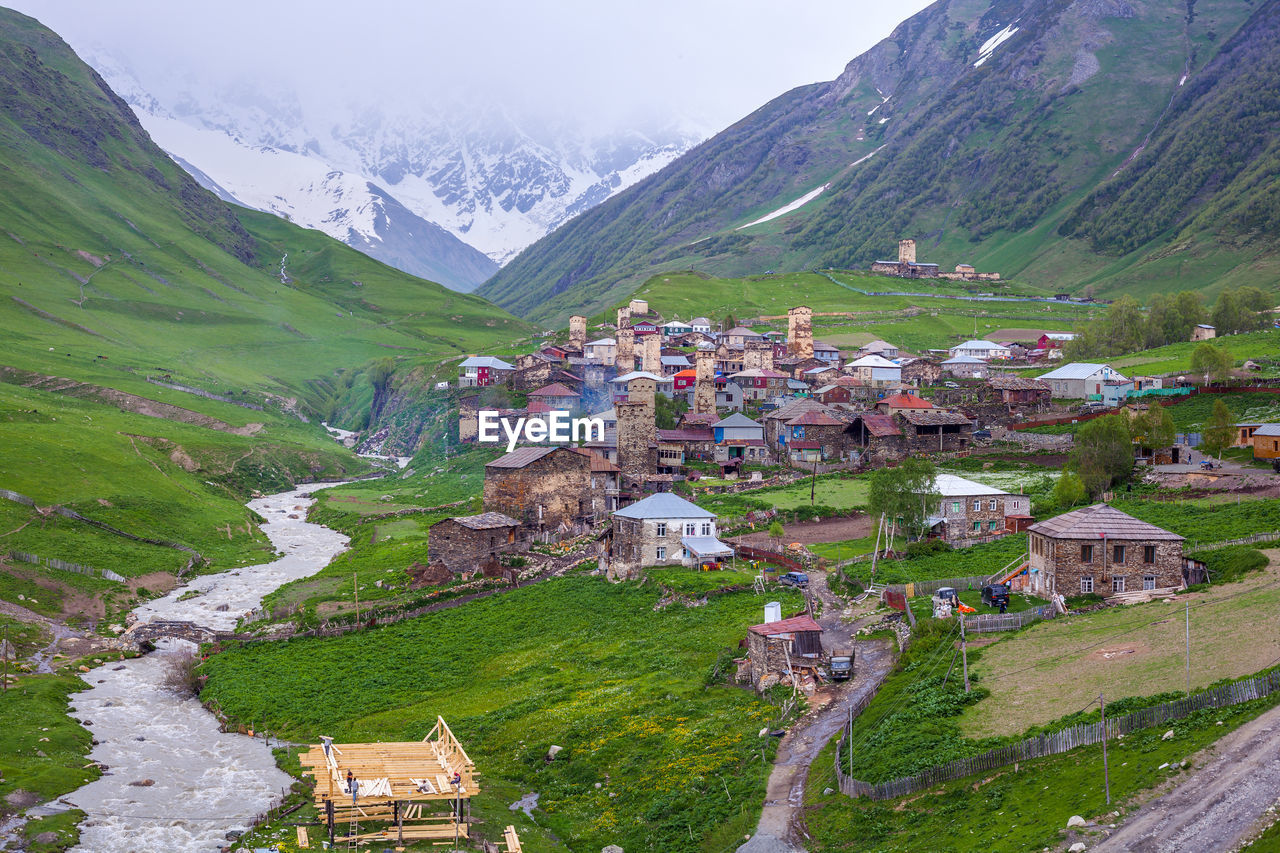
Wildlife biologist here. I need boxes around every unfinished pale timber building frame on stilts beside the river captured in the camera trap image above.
[300,716,479,847]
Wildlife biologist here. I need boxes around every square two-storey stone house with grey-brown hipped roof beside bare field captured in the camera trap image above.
[1027,503,1184,598]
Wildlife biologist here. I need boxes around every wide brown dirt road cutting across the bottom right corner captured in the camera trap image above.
[1091,708,1280,853]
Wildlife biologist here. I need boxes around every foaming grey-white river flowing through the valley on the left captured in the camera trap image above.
[61,484,347,853]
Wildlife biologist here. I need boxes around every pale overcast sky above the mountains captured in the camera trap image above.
[0,0,927,131]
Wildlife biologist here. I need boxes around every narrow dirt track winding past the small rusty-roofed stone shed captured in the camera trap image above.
[737,571,895,853]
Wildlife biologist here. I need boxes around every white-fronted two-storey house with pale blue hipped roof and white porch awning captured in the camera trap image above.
[607,492,733,580]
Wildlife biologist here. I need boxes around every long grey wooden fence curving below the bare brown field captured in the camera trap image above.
[836,670,1280,799]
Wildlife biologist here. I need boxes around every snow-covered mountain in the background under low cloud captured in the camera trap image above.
[88,53,705,291]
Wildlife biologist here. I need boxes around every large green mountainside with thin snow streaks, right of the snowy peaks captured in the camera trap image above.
[479,0,1280,319]
